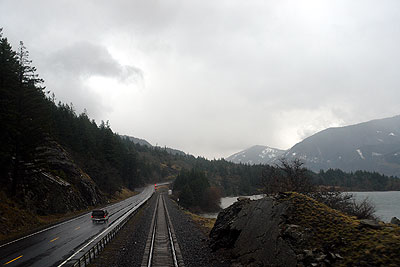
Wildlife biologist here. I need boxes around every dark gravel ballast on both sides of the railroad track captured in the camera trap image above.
[91,194,230,267]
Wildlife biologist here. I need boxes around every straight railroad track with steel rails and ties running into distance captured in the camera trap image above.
[141,194,184,267]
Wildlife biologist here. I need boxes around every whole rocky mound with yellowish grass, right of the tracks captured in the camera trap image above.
[210,193,400,266]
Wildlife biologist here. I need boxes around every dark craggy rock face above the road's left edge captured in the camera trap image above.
[22,142,106,215]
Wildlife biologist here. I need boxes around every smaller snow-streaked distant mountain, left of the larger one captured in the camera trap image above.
[226,146,285,164]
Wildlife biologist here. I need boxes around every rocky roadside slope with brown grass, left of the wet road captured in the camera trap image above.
[0,141,107,241]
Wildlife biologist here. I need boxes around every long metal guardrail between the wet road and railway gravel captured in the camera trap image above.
[71,194,153,267]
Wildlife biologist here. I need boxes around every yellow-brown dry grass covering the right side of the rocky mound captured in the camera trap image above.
[284,193,400,266]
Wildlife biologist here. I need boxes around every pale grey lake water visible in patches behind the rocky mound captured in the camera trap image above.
[202,191,400,222]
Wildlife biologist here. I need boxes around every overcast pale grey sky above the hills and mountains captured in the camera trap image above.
[0,0,400,159]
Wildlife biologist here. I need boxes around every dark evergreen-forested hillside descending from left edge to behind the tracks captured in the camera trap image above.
[0,28,261,206]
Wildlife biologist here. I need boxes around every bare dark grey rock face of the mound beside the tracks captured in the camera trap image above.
[210,198,297,266]
